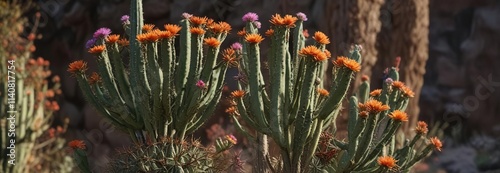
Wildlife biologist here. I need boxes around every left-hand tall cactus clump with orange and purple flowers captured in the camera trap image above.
[68,0,232,143]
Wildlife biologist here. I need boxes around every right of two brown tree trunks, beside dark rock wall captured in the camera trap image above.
[390,0,429,135]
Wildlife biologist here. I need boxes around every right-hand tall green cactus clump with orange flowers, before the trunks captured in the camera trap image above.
[226,13,440,172]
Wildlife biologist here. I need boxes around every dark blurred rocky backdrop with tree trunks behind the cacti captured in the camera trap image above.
[6,0,500,173]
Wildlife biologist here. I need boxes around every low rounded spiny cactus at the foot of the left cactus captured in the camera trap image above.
[107,135,237,172]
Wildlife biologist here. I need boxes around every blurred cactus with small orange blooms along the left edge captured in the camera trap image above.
[0,1,72,173]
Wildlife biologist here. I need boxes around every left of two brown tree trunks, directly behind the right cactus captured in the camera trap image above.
[318,0,384,86]
